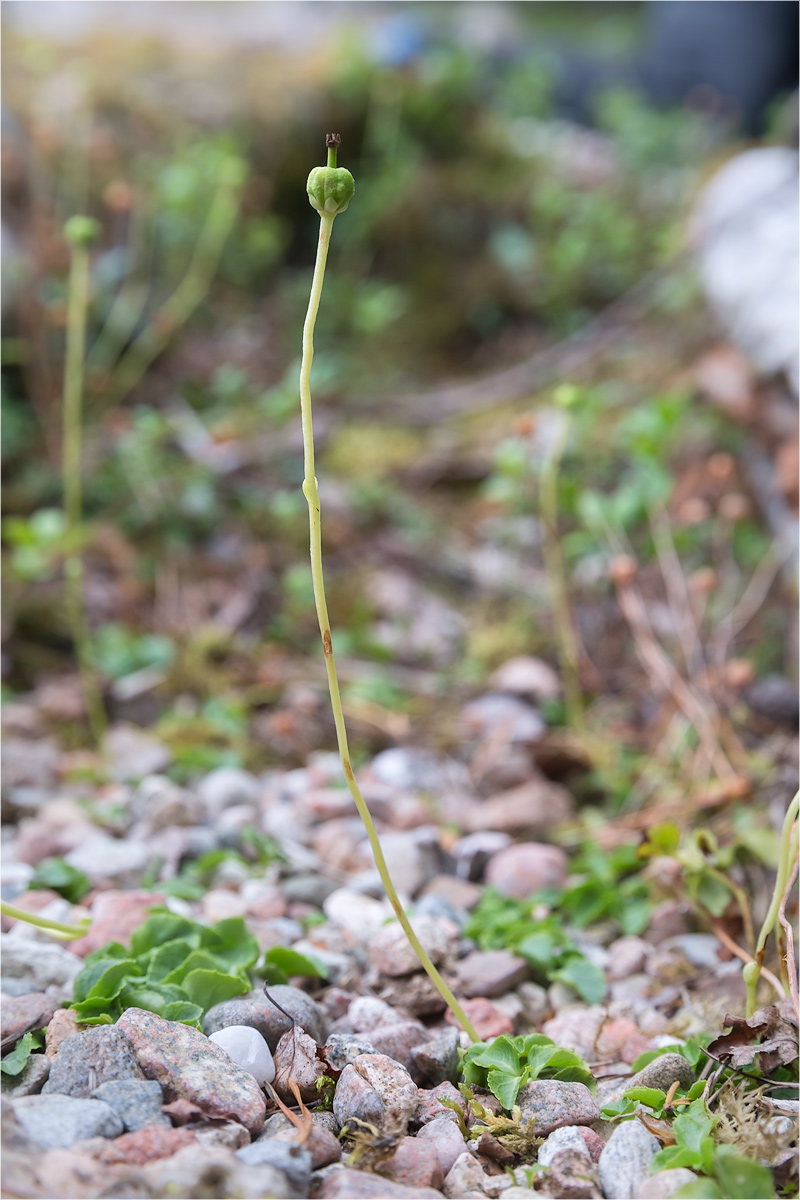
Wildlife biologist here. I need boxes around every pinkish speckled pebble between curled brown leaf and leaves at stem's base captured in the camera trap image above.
[333,1054,419,1136]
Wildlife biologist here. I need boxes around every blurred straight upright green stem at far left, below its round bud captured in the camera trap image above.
[62,235,107,749]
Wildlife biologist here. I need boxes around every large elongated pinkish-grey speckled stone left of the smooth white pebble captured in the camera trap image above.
[116,1008,266,1134]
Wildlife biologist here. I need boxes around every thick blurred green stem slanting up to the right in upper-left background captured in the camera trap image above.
[106,175,240,403]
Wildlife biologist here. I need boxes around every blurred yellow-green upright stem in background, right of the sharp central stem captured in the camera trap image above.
[539,418,583,730]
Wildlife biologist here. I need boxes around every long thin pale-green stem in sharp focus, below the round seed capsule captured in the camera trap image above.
[300,212,480,1042]
